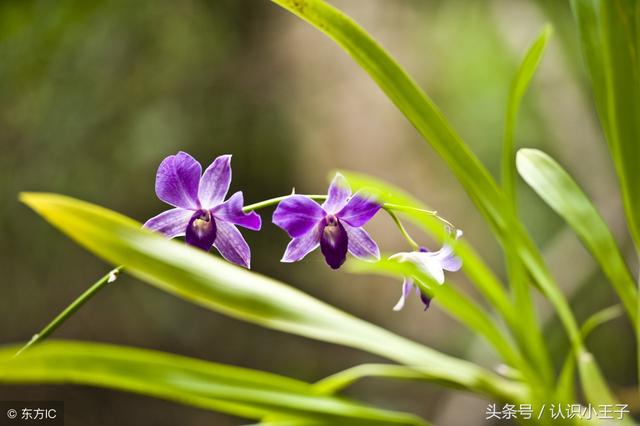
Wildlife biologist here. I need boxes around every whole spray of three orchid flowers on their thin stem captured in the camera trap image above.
[144,151,462,310]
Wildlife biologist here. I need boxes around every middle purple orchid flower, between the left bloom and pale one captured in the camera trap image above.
[273,173,381,269]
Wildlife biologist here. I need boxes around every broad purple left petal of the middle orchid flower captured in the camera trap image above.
[273,195,325,238]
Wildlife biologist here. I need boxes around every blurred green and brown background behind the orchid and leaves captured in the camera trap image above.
[0,0,638,425]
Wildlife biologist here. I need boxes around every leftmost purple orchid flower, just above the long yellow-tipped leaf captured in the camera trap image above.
[144,151,261,268]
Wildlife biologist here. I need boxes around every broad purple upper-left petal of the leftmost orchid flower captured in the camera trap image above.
[156,151,202,210]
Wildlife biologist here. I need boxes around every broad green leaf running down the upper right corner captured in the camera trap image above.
[571,0,640,250]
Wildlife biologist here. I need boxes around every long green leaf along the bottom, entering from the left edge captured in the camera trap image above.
[0,341,424,425]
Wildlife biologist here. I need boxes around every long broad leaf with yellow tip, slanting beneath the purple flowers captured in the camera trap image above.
[21,193,523,399]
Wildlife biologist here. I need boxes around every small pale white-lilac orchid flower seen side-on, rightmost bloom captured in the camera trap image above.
[389,229,462,311]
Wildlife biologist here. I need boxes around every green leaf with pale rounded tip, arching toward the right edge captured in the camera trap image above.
[517,149,638,326]
